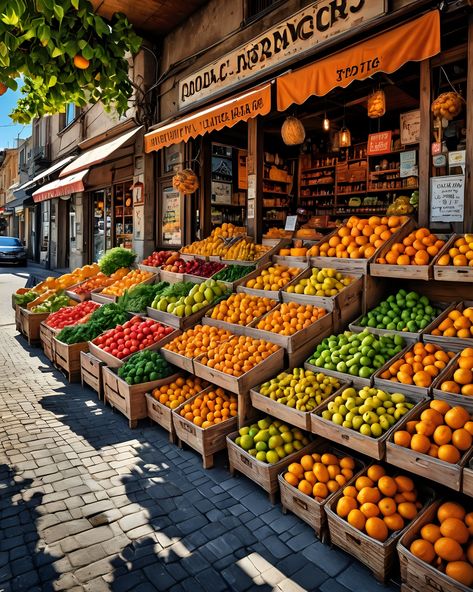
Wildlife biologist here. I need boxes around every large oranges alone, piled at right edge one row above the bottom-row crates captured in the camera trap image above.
[394,399,473,464]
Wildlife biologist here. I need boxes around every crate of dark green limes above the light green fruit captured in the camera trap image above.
[349,289,445,341]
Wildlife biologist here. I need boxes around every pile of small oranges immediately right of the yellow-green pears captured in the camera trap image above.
[210,292,277,326]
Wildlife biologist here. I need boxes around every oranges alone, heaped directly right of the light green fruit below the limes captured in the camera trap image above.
[380,343,455,388]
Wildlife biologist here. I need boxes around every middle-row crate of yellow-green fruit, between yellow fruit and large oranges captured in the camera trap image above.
[311,386,425,460]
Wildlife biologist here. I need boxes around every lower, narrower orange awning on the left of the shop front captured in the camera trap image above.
[145,84,271,152]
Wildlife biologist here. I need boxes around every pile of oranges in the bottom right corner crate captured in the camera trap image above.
[409,501,473,587]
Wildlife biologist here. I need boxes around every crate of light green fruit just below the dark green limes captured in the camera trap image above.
[304,329,405,387]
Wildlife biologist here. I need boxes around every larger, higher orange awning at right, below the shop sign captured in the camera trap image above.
[277,10,440,111]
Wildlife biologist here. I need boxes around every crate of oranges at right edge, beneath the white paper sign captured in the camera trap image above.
[434,234,473,282]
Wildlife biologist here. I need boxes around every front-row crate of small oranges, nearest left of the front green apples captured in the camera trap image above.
[172,385,238,469]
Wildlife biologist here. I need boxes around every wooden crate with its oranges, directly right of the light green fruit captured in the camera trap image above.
[374,341,455,396]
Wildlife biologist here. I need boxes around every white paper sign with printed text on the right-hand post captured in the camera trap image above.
[430,175,465,222]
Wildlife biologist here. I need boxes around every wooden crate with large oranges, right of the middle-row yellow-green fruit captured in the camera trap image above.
[386,399,473,491]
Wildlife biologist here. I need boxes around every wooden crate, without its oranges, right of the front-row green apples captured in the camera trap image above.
[278,440,366,542]
